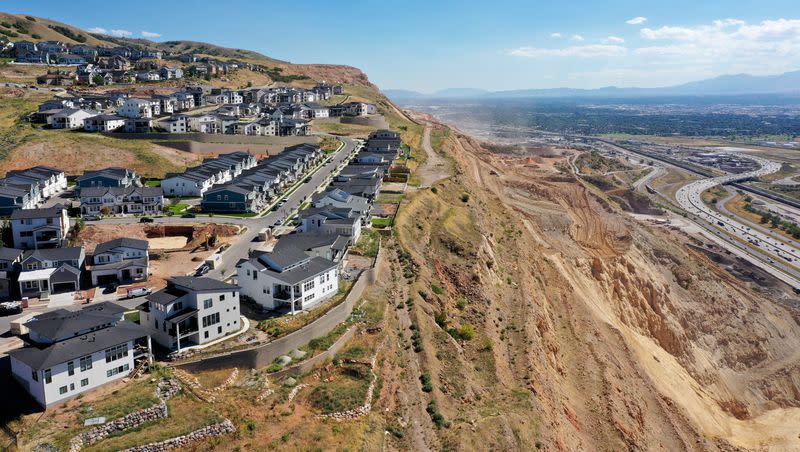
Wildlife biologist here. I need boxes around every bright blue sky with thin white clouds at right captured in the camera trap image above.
[6,0,800,92]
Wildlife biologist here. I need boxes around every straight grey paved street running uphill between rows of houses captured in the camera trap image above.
[206,138,358,279]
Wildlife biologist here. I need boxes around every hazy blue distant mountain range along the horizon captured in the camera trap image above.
[383,71,800,100]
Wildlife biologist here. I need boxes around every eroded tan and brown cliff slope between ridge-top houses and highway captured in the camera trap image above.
[384,128,800,450]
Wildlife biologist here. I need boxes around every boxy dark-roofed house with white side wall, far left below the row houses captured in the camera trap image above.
[10,204,70,249]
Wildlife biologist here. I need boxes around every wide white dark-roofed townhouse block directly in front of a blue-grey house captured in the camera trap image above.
[80,185,164,217]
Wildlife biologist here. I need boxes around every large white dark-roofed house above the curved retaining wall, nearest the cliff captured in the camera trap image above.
[236,240,339,315]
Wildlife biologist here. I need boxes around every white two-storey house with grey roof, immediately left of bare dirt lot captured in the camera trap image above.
[89,238,150,286]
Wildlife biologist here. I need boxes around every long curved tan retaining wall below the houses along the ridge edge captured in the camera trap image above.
[175,247,384,371]
